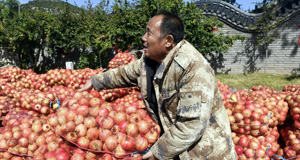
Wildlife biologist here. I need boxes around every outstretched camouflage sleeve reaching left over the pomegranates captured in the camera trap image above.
[91,58,142,91]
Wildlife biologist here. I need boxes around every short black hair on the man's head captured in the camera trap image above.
[155,11,184,44]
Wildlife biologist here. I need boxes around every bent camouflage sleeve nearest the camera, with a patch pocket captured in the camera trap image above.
[151,63,216,159]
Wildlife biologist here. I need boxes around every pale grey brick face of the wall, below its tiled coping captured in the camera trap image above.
[216,15,300,74]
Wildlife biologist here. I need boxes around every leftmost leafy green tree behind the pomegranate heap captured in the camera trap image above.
[2,10,51,71]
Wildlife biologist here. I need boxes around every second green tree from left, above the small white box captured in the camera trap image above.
[47,3,85,68]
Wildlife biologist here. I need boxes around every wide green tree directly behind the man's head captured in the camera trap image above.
[101,0,242,55]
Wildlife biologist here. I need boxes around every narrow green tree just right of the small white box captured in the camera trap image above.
[77,0,112,69]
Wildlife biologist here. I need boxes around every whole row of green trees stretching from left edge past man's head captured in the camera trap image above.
[0,0,242,71]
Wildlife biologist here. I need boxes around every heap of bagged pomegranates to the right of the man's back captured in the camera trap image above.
[218,82,300,160]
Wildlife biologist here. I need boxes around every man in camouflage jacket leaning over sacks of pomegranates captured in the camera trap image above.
[80,12,237,160]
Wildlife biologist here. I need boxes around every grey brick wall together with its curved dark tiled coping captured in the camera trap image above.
[196,0,300,74]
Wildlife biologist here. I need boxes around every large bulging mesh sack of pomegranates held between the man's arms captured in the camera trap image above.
[48,90,160,158]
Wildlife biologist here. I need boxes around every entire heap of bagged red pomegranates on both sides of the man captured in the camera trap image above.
[0,49,300,160]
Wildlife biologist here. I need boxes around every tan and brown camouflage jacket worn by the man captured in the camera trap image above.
[91,40,237,160]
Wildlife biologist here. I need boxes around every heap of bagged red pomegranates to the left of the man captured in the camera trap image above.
[0,53,160,160]
